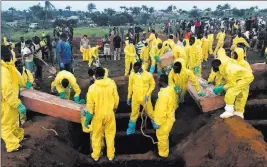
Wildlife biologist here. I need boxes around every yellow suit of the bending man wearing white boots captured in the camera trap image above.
[219,61,254,113]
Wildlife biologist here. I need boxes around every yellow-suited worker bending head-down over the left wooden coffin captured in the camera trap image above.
[51,70,85,104]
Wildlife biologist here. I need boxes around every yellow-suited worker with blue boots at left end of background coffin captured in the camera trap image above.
[149,43,165,74]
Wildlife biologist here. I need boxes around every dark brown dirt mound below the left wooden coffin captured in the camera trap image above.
[1,116,79,167]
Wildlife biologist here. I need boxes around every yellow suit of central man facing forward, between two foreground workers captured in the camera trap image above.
[127,71,155,122]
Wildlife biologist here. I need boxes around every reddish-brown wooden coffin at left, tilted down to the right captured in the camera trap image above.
[20,89,85,123]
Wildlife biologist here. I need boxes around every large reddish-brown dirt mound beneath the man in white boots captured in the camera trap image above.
[175,117,267,167]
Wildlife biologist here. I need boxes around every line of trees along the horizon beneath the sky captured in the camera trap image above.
[2,1,267,26]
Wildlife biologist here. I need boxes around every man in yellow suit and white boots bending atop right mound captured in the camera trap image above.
[211,59,254,118]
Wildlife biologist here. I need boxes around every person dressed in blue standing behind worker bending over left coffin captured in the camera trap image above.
[56,33,73,73]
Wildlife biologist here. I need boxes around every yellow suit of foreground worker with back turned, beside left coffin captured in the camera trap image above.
[86,78,119,160]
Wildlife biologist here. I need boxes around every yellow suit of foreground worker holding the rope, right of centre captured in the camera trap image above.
[154,86,177,157]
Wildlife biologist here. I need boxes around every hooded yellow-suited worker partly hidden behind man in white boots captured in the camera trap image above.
[231,48,252,72]
